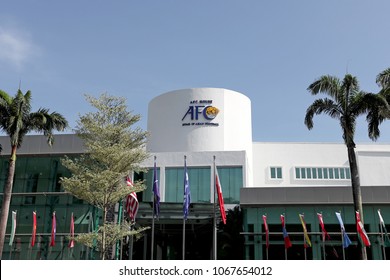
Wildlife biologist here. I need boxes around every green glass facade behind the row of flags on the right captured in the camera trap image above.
[244,205,390,260]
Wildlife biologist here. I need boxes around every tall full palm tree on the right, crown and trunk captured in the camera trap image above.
[305,74,386,259]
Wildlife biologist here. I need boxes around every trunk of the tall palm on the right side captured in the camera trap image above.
[347,146,367,260]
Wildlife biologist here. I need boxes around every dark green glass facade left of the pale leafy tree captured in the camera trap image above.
[0,156,93,259]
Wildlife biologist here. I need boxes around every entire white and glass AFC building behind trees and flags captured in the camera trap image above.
[0,88,390,260]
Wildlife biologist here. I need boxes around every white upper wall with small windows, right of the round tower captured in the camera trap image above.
[253,142,390,187]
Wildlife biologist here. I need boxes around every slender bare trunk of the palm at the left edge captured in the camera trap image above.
[0,146,16,260]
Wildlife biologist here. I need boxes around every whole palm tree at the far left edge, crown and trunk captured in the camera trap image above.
[0,89,68,259]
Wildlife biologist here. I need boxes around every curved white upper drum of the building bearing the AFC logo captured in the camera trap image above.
[147,88,252,155]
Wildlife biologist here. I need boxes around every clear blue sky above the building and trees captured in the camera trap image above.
[0,0,390,143]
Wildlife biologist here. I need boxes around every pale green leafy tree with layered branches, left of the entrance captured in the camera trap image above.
[61,94,148,259]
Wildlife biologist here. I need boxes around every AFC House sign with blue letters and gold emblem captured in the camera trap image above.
[181,100,219,126]
